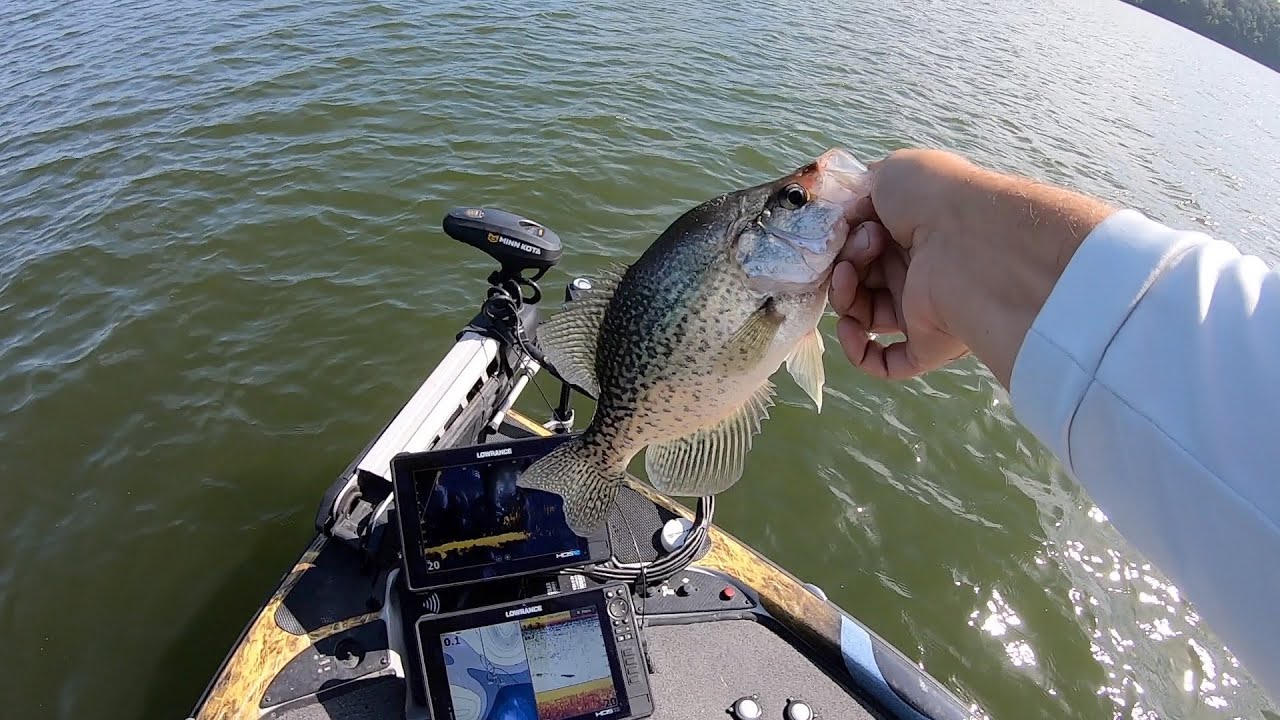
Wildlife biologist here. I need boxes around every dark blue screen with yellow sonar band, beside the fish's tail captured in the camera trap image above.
[406,459,590,587]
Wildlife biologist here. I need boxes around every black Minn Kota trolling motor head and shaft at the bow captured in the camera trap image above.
[442,208,581,422]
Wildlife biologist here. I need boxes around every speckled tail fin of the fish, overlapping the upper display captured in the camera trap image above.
[516,436,627,537]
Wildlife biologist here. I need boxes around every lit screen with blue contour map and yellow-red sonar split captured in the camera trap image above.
[440,607,620,720]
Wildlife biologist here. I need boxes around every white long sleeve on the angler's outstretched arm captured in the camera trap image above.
[1010,210,1280,700]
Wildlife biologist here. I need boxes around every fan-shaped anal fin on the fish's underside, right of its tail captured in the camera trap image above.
[644,380,773,497]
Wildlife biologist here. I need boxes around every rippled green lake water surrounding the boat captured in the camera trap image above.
[0,0,1280,720]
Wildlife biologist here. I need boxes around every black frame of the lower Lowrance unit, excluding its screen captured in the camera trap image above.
[415,585,631,720]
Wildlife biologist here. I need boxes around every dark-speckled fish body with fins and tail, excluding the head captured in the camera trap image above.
[521,165,824,534]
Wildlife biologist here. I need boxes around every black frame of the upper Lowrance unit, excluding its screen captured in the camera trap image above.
[392,432,609,592]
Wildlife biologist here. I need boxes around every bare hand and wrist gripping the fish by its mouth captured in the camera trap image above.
[829,150,1112,388]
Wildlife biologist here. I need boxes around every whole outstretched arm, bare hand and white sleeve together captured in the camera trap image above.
[855,150,1280,693]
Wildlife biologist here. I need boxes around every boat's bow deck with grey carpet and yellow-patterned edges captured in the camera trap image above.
[192,386,969,720]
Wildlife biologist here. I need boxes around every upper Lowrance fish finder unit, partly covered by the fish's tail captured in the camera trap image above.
[392,433,609,592]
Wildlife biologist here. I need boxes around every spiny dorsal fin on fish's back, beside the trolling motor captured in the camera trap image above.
[538,265,626,397]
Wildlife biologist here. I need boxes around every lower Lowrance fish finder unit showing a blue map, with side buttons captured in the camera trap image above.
[417,583,653,720]
